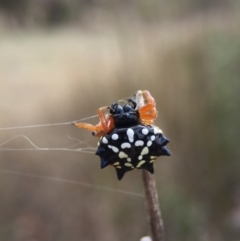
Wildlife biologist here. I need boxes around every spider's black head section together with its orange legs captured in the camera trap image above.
[74,90,157,137]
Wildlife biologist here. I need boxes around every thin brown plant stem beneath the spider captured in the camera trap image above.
[142,170,164,241]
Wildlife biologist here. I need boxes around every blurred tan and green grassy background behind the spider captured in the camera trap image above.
[0,0,240,241]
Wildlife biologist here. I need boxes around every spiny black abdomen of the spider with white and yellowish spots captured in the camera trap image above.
[96,125,170,180]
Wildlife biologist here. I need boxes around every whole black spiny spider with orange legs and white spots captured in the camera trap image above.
[74,90,170,180]
